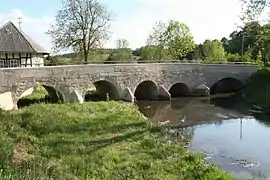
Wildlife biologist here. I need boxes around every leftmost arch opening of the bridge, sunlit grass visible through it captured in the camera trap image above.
[15,84,65,108]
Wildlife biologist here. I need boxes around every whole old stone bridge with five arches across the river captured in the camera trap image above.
[0,63,258,109]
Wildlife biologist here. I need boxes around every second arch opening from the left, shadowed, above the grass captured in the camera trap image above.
[84,79,120,101]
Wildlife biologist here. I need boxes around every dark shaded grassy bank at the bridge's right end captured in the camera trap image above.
[245,69,270,109]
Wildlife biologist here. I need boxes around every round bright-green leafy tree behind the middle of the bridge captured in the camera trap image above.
[147,21,195,60]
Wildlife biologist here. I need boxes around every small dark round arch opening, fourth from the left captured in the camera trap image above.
[169,83,191,98]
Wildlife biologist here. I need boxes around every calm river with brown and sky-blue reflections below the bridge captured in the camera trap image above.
[137,96,270,180]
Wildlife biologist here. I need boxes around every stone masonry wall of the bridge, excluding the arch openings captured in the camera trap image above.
[0,63,257,109]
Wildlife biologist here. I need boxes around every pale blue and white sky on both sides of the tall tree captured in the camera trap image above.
[0,0,244,51]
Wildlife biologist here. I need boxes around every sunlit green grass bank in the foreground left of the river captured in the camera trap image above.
[0,102,231,180]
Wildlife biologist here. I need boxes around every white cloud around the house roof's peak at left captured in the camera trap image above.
[0,9,53,51]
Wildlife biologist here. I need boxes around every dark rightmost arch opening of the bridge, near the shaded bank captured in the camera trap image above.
[210,77,244,95]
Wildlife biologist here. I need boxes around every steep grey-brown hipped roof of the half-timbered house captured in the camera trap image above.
[0,22,48,54]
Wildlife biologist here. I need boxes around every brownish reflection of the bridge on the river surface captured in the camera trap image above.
[137,97,244,128]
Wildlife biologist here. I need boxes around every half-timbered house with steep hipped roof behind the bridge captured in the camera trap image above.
[0,22,49,68]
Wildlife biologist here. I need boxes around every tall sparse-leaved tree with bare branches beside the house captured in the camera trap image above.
[47,0,111,62]
